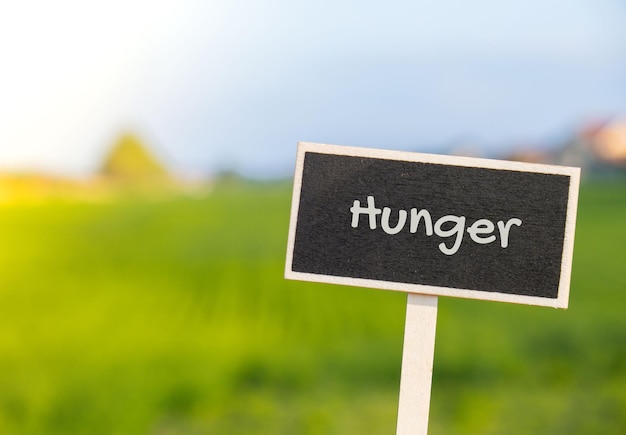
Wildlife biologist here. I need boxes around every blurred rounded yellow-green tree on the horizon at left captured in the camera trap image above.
[101,132,172,183]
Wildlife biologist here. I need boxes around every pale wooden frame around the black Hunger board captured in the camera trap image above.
[285,142,580,308]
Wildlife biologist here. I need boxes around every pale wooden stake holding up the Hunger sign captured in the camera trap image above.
[396,293,437,435]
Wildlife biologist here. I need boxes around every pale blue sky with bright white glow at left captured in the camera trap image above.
[0,0,626,177]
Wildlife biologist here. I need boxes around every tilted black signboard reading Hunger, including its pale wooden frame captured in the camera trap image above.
[285,143,580,308]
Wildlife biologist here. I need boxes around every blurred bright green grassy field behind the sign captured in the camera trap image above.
[0,184,626,435]
